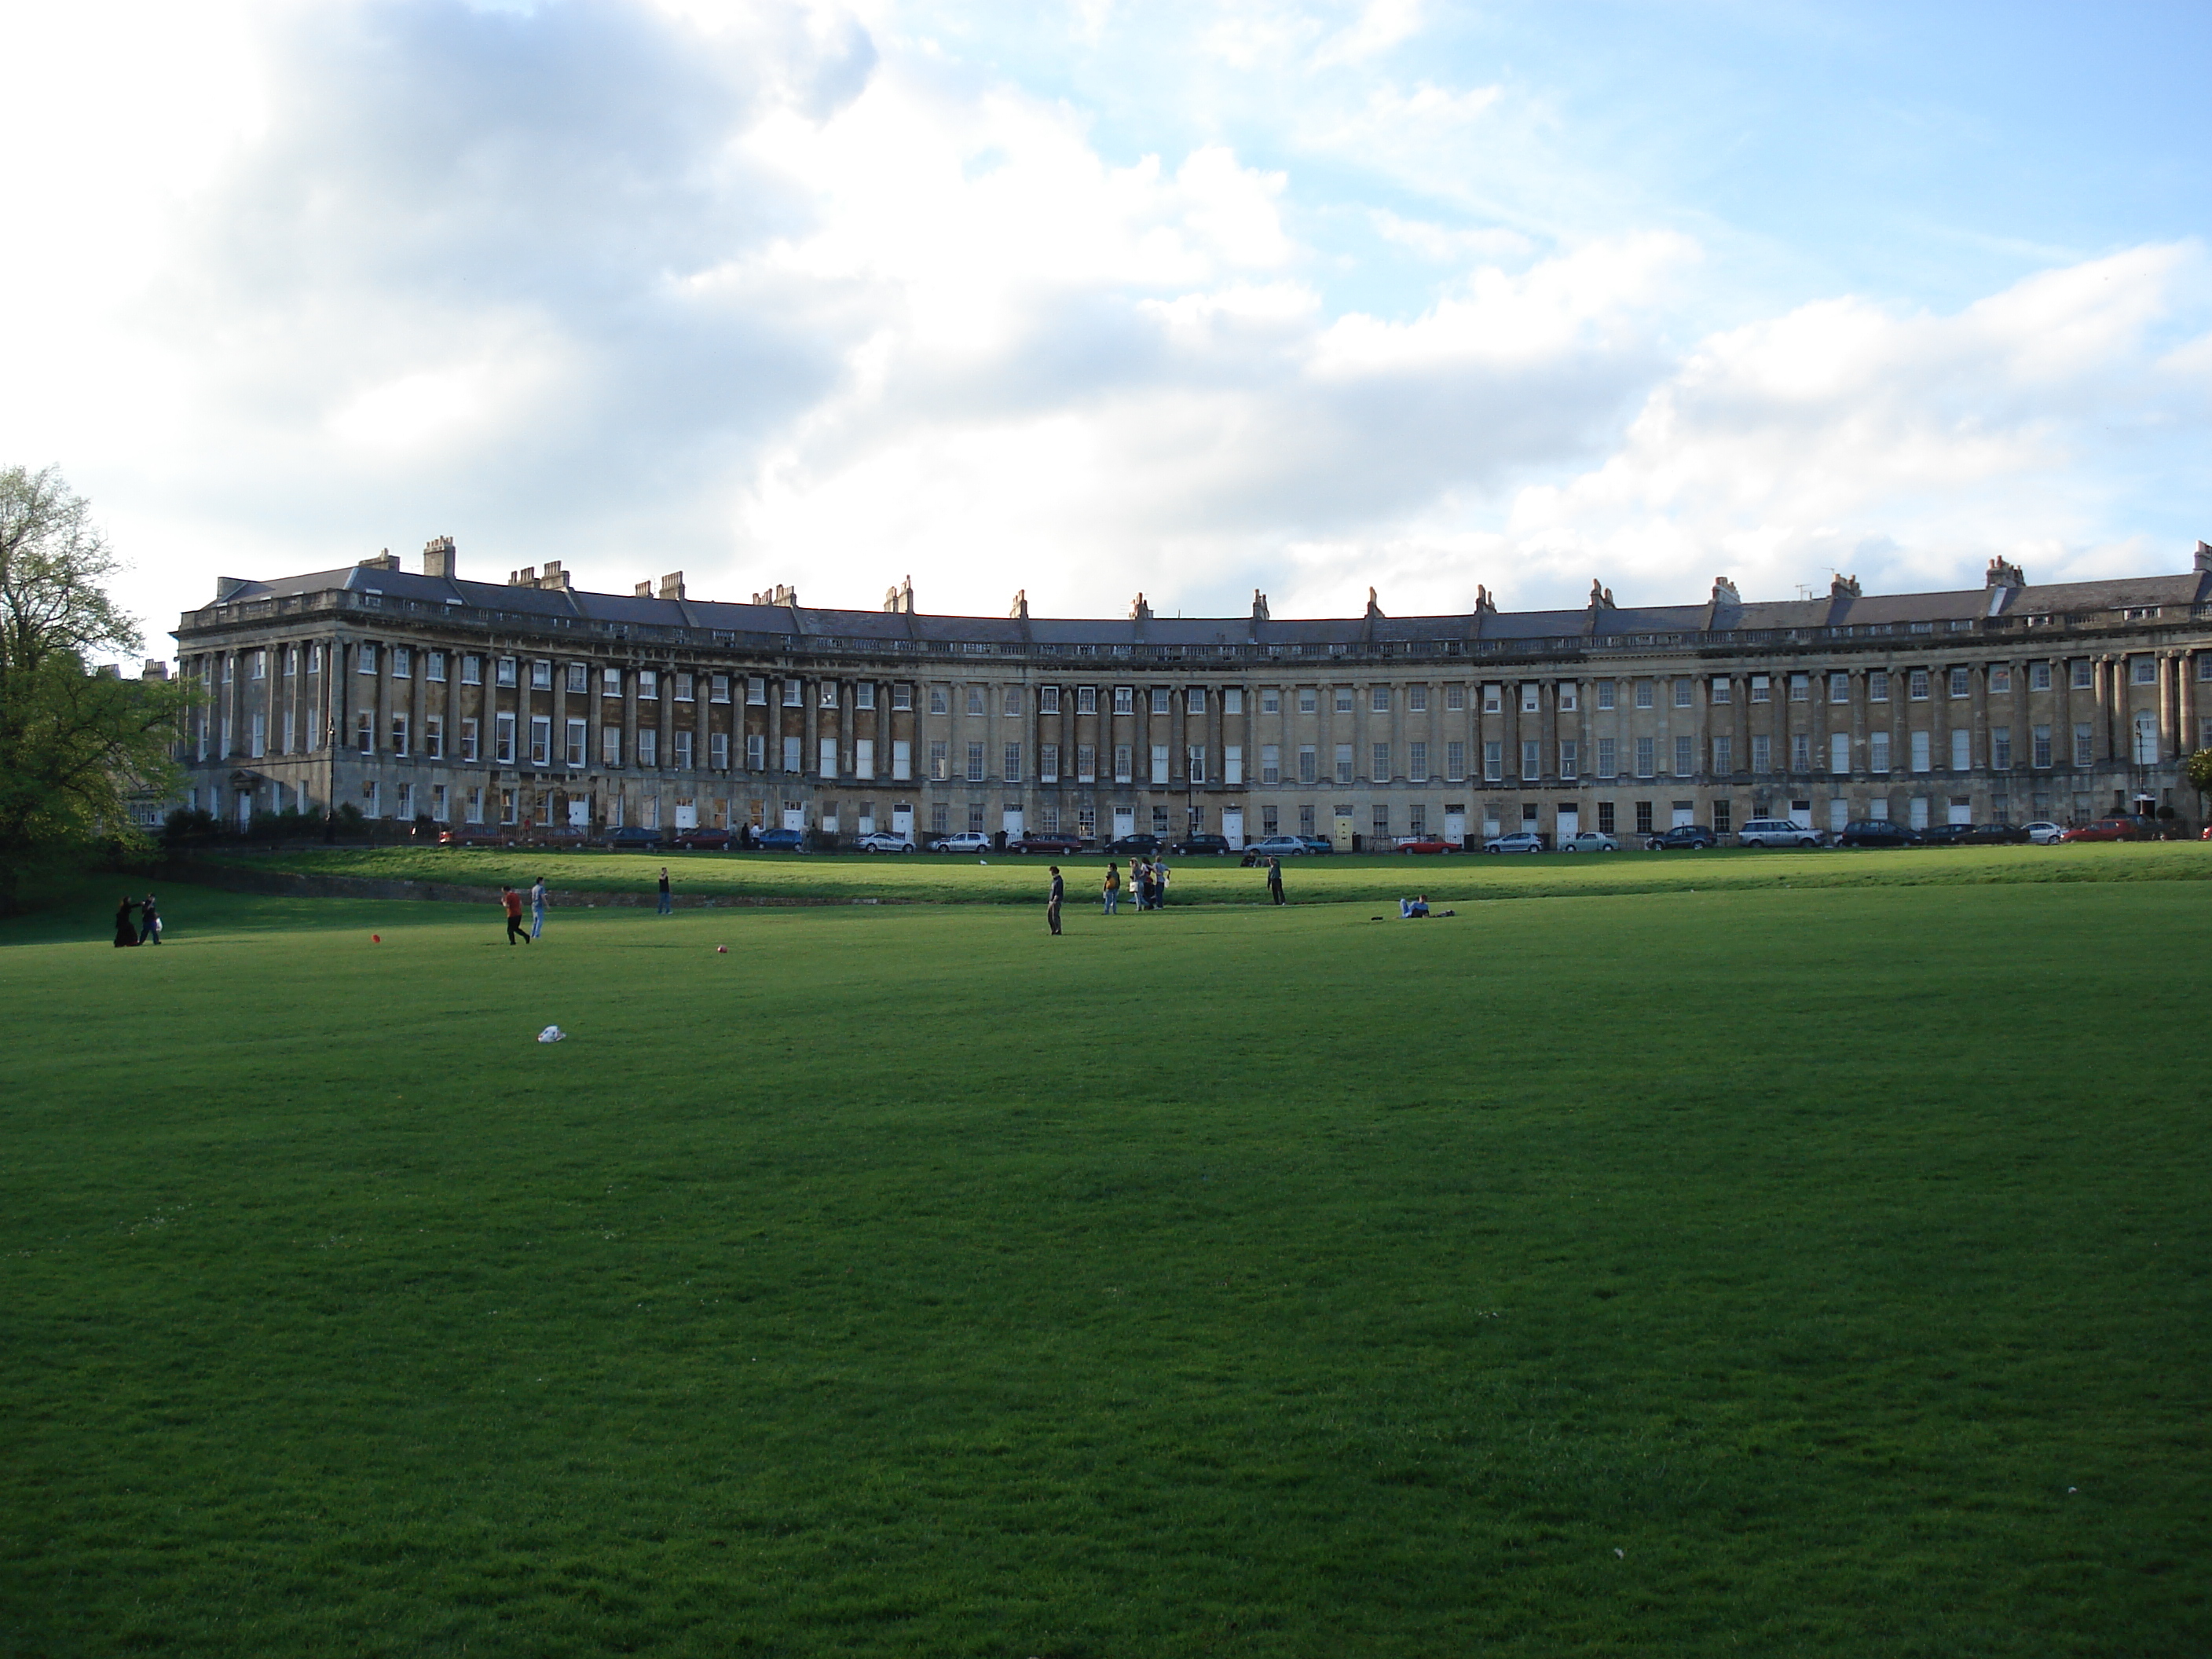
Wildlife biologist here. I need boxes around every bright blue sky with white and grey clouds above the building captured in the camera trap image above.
[0,0,2212,655]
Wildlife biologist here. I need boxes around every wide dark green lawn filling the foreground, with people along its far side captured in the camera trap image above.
[0,876,2212,1659]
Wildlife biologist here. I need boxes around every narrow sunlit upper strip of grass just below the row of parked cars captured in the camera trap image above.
[194,840,2212,905]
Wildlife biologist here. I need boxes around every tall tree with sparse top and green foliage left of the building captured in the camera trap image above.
[0,467,186,911]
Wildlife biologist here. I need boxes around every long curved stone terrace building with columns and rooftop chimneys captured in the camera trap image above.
[177,537,2212,843]
